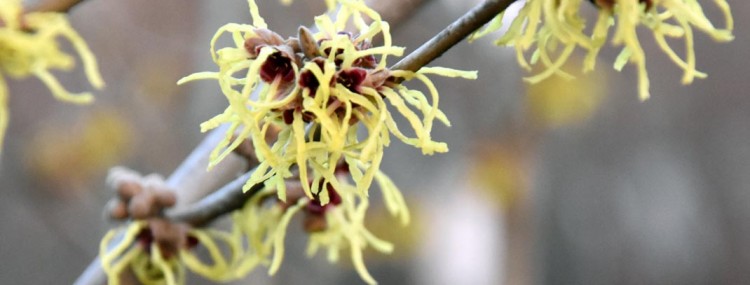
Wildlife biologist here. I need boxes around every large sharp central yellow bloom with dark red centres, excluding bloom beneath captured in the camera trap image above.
[178,1,476,204]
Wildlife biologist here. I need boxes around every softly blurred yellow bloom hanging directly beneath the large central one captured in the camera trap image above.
[234,164,409,284]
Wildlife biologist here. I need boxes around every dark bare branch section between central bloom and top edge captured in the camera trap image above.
[391,0,516,71]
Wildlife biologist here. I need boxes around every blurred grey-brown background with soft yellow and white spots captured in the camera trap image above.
[0,0,750,284]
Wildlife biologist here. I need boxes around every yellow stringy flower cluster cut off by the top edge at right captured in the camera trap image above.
[472,0,734,100]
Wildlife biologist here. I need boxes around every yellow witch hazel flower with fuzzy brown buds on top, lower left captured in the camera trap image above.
[99,167,248,285]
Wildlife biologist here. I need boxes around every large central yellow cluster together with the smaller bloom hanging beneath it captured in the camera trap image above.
[173,0,476,283]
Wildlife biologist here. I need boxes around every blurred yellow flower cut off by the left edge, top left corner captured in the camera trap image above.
[0,0,104,149]
